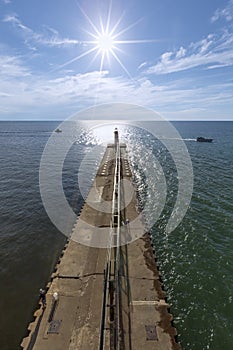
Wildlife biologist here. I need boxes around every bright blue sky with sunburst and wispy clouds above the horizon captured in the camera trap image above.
[0,0,233,120]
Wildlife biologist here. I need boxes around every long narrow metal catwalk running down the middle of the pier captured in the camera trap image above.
[99,137,121,350]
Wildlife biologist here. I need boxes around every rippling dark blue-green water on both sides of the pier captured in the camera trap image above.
[0,122,233,350]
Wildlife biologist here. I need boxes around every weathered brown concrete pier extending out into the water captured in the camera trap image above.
[21,135,181,350]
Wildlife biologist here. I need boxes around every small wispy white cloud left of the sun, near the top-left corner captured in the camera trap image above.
[3,14,81,47]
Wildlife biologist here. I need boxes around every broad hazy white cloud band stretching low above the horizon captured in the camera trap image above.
[0,52,233,118]
